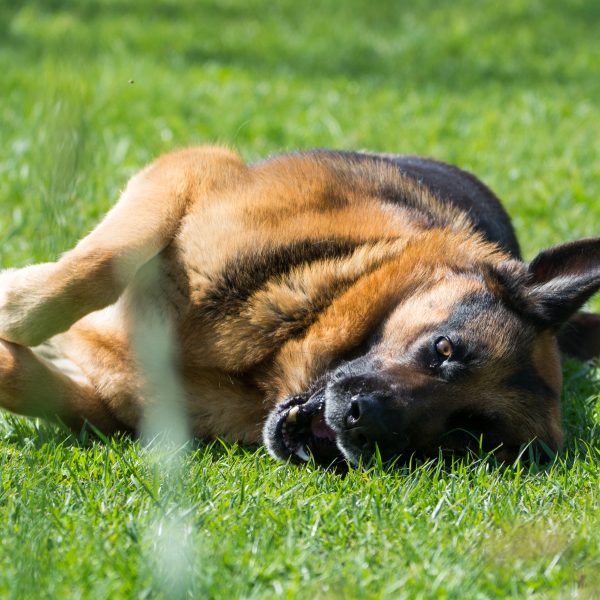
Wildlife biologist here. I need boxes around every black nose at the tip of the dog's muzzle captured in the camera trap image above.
[344,392,389,448]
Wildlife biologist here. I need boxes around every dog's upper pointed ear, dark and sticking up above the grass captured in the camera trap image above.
[525,237,600,326]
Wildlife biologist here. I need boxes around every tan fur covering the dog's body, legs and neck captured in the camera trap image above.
[0,147,576,460]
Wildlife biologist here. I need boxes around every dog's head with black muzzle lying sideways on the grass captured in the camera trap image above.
[264,238,600,465]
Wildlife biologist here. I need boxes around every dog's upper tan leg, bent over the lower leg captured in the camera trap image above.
[0,147,247,346]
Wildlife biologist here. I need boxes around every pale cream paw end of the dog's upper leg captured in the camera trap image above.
[0,263,61,346]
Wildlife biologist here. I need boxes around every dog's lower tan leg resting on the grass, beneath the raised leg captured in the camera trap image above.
[0,340,127,434]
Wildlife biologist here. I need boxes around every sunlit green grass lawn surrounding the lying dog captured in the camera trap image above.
[0,0,600,599]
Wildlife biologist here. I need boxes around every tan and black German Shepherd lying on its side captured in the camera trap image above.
[0,147,600,466]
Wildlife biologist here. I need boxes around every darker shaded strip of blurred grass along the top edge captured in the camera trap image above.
[0,0,600,92]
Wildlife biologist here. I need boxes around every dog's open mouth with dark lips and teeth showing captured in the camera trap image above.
[264,391,344,467]
